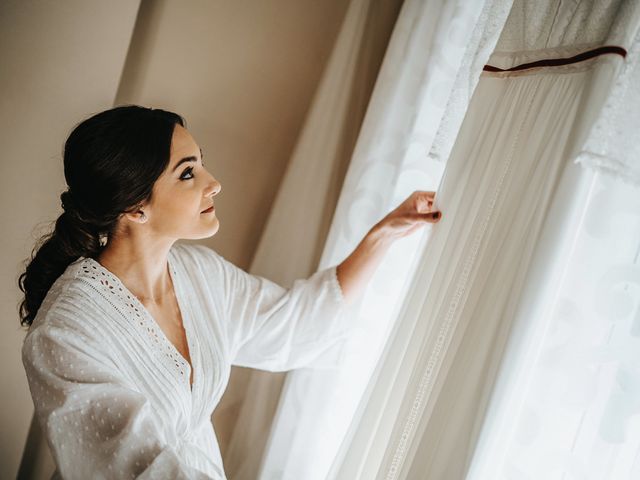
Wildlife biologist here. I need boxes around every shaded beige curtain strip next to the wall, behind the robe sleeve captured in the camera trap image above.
[214,0,402,480]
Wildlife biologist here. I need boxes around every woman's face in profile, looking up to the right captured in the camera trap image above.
[142,124,222,239]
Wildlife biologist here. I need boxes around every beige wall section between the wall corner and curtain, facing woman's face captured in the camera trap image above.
[117,0,349,268]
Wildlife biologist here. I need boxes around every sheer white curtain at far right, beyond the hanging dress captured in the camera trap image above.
[468,13,640,480]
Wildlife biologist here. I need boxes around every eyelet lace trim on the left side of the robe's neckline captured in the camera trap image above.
[79,257,191,383]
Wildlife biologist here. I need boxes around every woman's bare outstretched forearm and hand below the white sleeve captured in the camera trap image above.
[336,191,442,302]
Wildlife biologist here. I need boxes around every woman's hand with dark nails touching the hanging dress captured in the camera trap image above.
[372,190,442,240]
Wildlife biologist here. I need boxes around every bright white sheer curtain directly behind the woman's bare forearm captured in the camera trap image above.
[258,0,510,480]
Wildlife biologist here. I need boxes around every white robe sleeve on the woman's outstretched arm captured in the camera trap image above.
[192,246,353,371]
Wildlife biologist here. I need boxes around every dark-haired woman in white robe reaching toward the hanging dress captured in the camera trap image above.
[19,105,440,479]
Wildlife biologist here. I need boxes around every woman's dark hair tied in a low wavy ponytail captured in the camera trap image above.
[18,105,185,326]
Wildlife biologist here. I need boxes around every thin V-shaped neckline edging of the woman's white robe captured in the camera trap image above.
[86,250,196,394]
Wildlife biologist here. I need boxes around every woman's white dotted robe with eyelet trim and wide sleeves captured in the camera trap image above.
[22,243,351,480]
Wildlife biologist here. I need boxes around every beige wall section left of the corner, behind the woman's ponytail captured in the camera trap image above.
[0,0,138,478]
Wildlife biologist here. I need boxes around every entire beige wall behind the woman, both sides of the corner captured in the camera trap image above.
[0,0,348,478]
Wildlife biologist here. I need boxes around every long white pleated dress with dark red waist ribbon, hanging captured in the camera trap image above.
[332,0,638,480]
